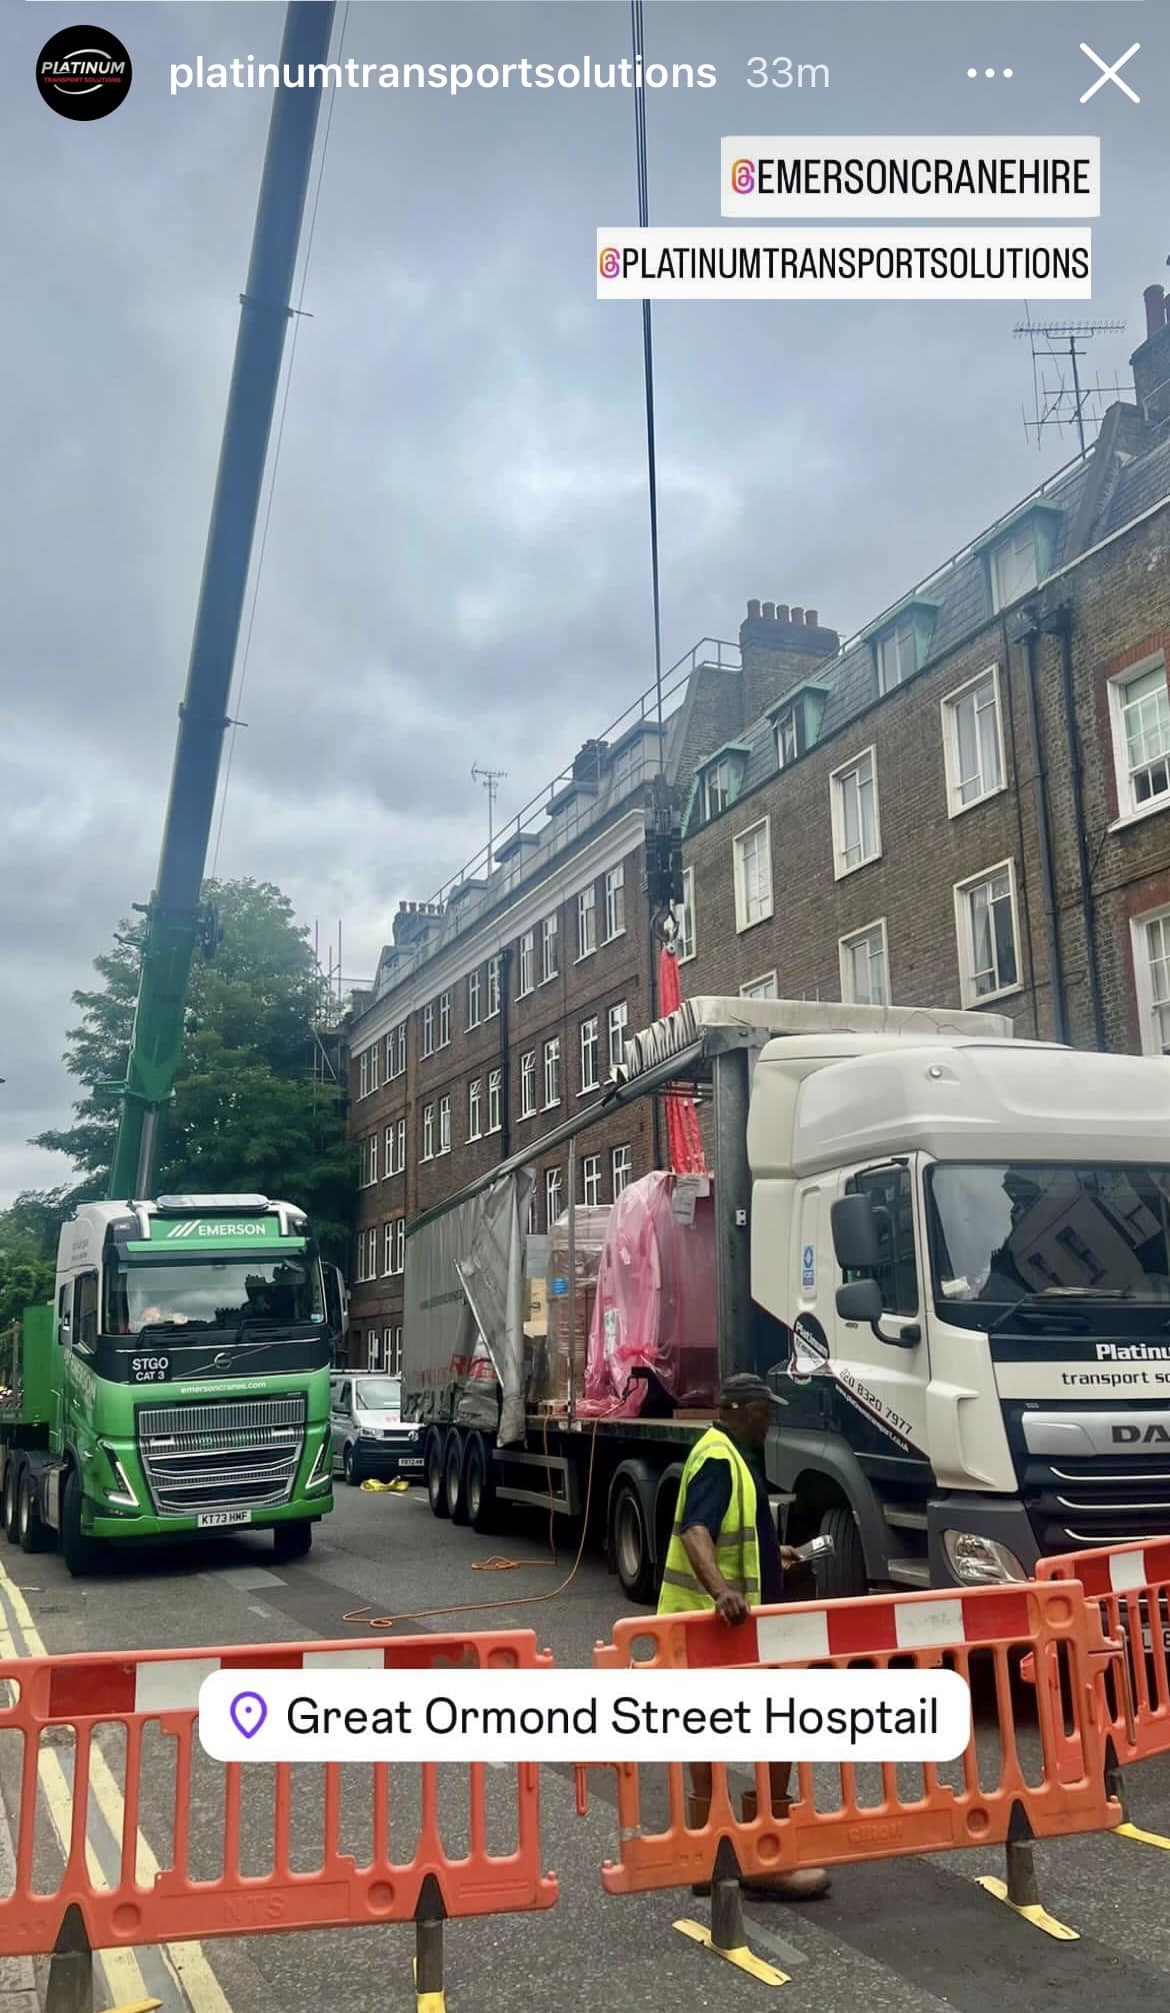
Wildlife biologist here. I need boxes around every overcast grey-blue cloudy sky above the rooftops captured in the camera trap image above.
[0,0,1170,1202]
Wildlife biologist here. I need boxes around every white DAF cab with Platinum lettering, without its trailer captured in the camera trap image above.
[747,1011,1170,1594]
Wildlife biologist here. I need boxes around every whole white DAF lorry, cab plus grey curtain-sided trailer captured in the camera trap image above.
[403,998,1170,1600]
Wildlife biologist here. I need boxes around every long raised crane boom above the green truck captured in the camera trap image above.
[107,0,334,1200]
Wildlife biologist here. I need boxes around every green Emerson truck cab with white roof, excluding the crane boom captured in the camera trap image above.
[0,1196,338,1576]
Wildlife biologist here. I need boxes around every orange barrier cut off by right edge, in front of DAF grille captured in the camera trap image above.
[1035,1538,1170,1763]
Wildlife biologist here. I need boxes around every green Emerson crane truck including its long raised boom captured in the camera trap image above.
[0,0,344,1574]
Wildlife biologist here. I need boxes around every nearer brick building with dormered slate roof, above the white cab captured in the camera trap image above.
[683,288,1170,1051]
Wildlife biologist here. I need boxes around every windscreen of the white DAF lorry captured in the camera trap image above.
[926,1162,1170,1325]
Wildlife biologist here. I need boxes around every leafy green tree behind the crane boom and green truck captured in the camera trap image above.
[36,880,356,1264]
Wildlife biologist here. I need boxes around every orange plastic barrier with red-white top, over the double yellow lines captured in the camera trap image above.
[0,1629,558,1955]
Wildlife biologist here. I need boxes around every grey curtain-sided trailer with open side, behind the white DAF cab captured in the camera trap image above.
[403,998,1009,1602]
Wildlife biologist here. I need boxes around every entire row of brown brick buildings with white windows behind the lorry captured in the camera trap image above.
[348,288,1170,1367]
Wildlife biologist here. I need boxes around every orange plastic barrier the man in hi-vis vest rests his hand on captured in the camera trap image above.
[578,1584,1124,1894]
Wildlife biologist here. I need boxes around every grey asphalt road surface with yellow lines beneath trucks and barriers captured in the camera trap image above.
[0,1486,1170,2013]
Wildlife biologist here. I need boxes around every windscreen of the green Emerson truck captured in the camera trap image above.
[105,1252,324,1335]
